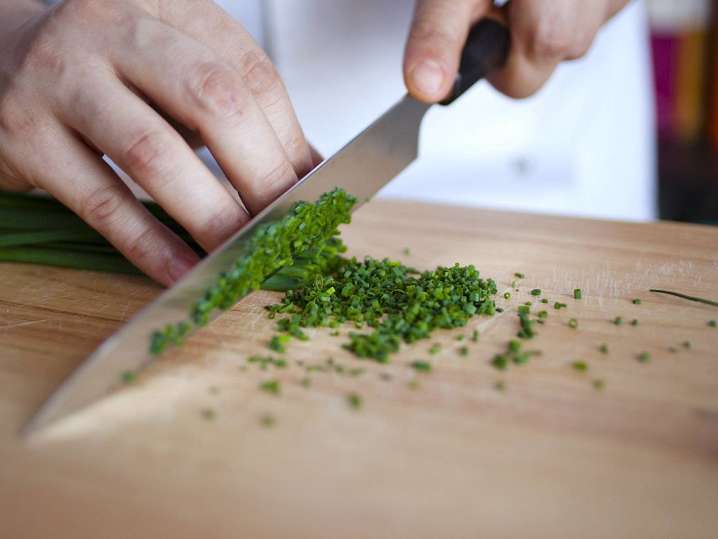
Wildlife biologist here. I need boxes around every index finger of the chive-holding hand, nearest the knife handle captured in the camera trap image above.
[162,1,313,178]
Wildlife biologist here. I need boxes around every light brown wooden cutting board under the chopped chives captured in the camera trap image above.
[0,202,718,539]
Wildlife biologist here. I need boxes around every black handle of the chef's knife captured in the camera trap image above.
[441,19,511,105]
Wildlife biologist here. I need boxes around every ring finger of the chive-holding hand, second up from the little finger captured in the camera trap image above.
[59,75,249,251]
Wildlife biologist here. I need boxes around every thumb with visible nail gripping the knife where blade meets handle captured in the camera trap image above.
[404,0,492,103]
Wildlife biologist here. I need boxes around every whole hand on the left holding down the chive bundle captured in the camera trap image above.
[0,0,313,285]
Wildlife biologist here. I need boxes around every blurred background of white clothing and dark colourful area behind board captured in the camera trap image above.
[220,0,718,222]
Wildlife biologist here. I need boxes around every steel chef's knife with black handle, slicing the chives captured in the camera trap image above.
[25,19,510,433]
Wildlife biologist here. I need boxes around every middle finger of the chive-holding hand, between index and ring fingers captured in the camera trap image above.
[116,17,297,214]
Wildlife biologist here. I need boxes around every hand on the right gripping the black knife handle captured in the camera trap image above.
[404,0,629,103]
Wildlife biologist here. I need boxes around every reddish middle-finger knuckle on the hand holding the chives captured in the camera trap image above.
[190,63,246,118]
